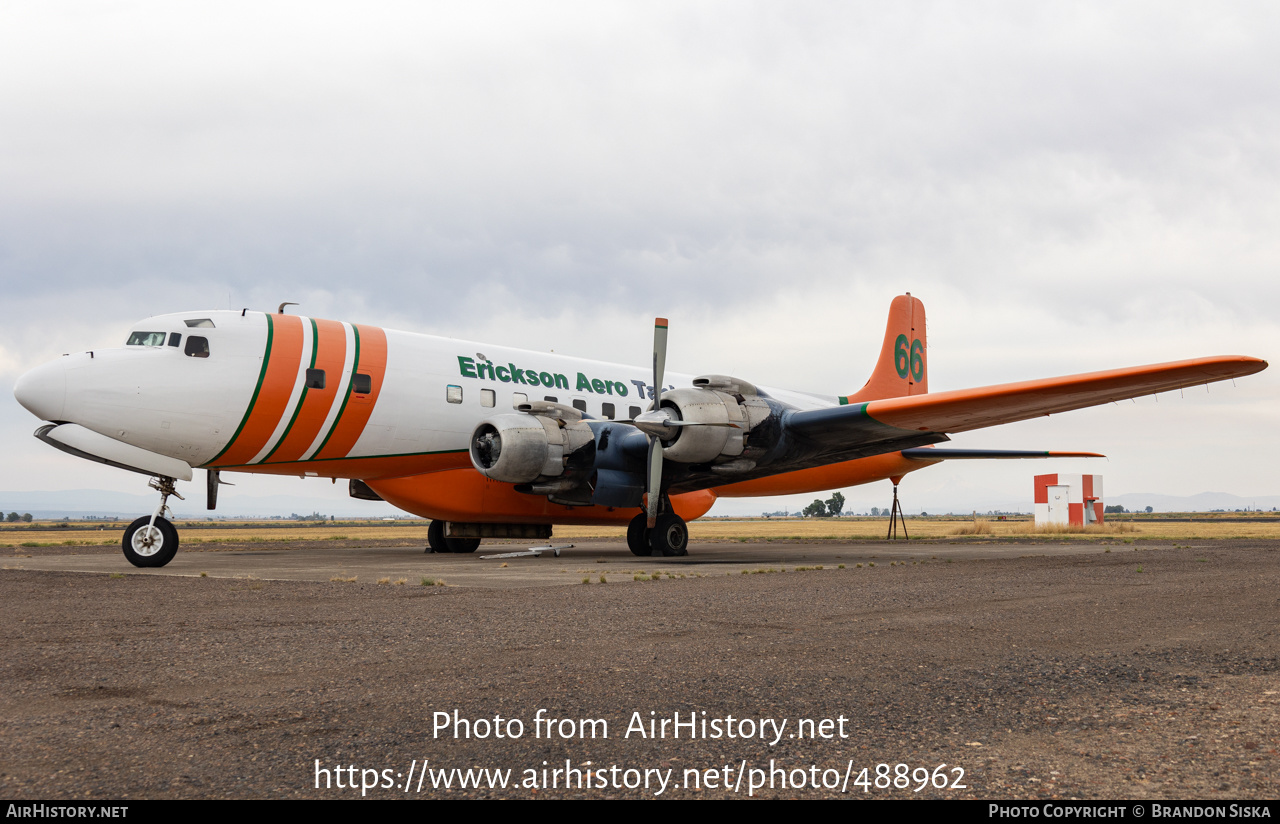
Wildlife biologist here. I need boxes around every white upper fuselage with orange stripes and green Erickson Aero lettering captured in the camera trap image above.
[15,311,836,477]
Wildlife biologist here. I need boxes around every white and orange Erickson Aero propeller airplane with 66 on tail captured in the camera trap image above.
[14,293,1267,567]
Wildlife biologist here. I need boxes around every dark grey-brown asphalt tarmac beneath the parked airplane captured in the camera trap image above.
[0,540,1280,802]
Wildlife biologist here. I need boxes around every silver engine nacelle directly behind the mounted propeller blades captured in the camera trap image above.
[662,375,771,463]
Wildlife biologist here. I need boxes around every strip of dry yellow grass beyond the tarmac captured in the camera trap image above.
[0,513,1280,548]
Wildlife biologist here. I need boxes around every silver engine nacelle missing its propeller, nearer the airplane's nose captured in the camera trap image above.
[470,404,595,484]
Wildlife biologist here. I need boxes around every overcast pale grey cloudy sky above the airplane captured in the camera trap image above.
[0,0,1280,512]
